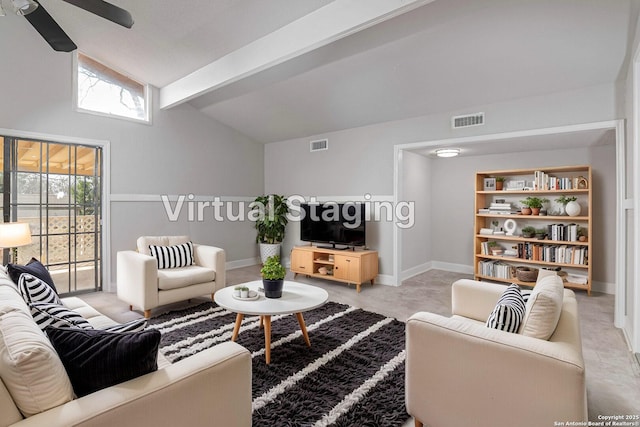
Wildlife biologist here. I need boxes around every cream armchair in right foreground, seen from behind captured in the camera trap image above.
[406,275,587,427]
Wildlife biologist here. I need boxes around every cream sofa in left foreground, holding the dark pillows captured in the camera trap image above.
[0,271,251,427]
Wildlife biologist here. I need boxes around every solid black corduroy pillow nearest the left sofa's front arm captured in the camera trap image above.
[45,327,160,397]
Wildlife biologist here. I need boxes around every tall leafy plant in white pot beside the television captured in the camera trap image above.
[251,194,289,264]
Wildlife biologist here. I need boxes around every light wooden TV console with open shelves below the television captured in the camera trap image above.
[291,246,378,292]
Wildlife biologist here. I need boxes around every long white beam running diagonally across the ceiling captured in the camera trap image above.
[160,0,434,109]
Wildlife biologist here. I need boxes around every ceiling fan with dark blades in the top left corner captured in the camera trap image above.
[0,0,133,52]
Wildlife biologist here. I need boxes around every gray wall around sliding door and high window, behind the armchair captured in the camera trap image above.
[0,17,264,286]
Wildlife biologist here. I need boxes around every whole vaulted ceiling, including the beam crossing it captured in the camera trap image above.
[5,0,638,143]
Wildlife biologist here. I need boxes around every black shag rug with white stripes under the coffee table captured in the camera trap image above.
[149,302,409,426]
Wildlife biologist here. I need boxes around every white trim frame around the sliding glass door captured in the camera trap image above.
[0,128,112,292]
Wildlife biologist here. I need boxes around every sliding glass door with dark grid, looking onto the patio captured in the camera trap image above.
[0,137,102,294]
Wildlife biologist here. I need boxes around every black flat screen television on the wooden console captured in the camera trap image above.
[300,203,366,248]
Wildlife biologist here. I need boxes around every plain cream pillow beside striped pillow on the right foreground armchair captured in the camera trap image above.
[519,274,564,340]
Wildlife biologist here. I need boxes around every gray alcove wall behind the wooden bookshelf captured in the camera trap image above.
[430,144,616,284]
